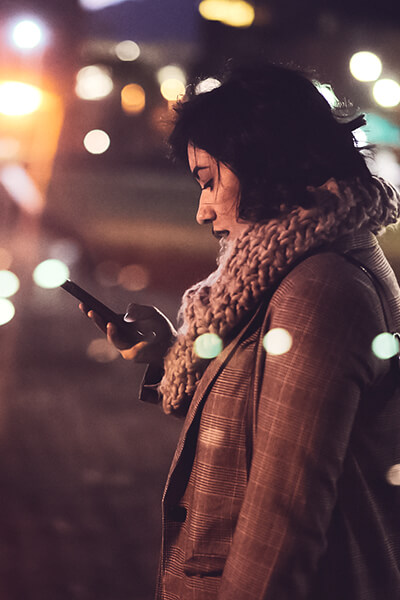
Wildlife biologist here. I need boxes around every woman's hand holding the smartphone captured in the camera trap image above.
[79,304,176,365]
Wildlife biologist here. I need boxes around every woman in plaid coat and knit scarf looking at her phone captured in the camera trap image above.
[84,65,400,600]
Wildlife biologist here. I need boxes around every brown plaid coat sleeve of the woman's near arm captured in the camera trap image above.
[218,255,388,600]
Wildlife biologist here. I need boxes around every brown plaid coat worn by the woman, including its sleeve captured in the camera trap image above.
[142,227,400,600]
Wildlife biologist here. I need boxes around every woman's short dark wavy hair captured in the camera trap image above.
[168,64,371,222]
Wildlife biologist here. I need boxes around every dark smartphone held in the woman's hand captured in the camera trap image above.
[60,279,145,345]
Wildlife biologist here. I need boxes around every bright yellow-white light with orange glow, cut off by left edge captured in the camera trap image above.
[0,81,43,117]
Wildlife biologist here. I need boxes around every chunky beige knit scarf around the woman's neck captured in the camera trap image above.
[160,177,400,413]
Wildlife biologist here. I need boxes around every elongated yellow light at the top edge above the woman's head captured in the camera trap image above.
[199,0,255,27]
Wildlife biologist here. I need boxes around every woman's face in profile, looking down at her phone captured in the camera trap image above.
[188,143,247,239]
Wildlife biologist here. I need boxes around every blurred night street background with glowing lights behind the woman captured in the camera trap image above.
[0,0,400,600]
